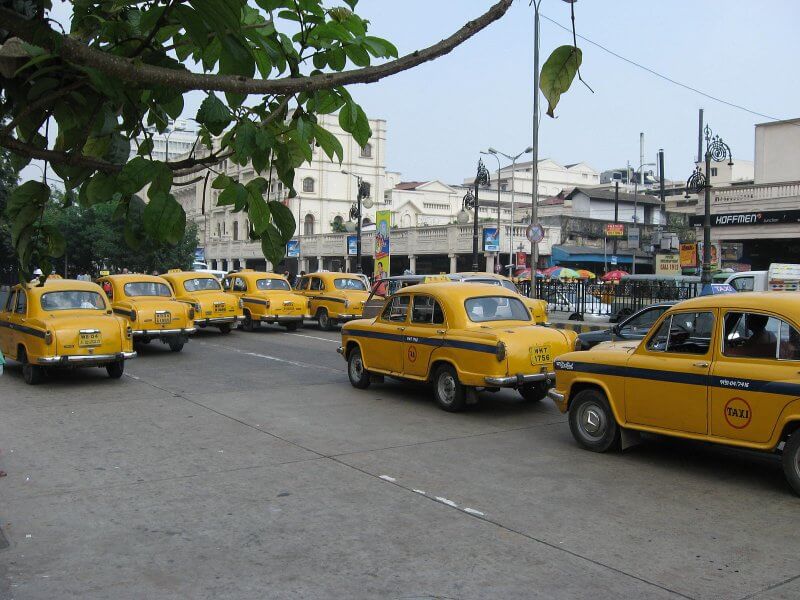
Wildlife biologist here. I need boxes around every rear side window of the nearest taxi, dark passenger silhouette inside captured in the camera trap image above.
[722,312,780,358]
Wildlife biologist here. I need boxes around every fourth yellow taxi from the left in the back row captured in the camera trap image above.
[222,269,308,331]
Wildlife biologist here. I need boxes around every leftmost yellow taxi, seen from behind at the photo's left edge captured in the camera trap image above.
[0,279,136,384]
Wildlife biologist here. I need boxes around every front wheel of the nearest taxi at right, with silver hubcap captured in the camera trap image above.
[569,389,620,452]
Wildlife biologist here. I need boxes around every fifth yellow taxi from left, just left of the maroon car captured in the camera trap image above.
[297,272,369,331]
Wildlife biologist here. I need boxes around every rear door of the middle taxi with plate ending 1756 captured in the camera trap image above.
[403,294,447,377]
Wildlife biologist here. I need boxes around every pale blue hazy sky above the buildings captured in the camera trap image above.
[23,0,800,183]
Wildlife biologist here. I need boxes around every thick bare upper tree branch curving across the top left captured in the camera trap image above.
[0,0,513,95]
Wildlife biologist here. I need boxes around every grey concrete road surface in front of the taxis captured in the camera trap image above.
[0,327,800,600]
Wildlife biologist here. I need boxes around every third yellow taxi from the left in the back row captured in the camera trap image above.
[162,269,243,333]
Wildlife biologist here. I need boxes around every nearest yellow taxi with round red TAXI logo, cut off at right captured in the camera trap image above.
[549,292,800,494]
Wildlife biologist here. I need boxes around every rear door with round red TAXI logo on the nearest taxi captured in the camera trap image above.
[710,309,800,442]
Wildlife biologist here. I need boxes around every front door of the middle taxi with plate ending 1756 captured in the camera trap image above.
[364,294,411,374]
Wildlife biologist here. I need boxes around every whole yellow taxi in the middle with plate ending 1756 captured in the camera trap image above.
[339,283,577,412]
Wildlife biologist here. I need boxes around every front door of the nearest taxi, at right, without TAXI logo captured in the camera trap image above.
[624,310,716,434]
